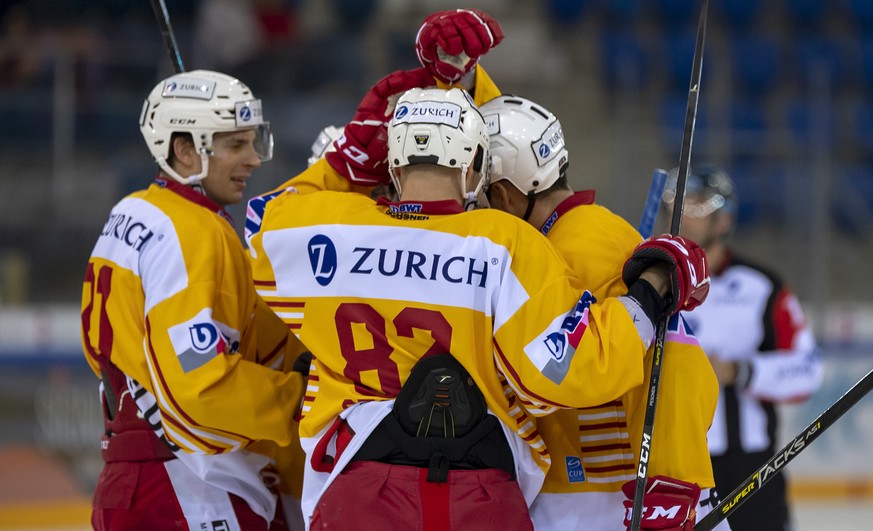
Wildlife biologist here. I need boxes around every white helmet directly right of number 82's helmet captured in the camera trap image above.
[481,95,569,195]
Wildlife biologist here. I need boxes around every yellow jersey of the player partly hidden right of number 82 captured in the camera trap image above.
[538,191,718,496]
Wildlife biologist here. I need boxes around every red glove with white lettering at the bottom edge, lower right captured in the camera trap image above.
[621,476,700,531]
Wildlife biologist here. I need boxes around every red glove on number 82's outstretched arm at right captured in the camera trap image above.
[622,234,709,315]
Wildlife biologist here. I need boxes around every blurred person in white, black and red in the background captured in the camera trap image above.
[664,164,823,531]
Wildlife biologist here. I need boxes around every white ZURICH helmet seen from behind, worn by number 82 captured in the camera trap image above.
[388,88,490,200]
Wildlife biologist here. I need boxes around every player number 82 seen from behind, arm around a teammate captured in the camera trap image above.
[251,89,707,530]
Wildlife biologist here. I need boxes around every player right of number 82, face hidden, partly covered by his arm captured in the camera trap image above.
[481,95,718,531]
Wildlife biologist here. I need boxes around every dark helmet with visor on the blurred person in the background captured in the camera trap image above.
[663,164,739,218]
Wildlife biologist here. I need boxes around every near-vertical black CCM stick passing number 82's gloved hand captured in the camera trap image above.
[630,0,709,531]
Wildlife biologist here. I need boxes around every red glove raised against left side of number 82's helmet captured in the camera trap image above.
[325,68,434,186]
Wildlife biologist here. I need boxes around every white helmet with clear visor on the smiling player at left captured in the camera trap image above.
[139,70,273,184]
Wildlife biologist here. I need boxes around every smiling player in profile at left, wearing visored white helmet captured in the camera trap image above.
[82,70,308,530]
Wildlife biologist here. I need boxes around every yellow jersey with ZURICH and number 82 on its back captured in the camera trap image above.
[251,192,653,514]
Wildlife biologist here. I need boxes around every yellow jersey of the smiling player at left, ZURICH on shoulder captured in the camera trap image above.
[82,179,303,455]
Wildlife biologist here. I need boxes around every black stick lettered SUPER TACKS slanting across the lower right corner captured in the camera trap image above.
[694,371,873,531]
